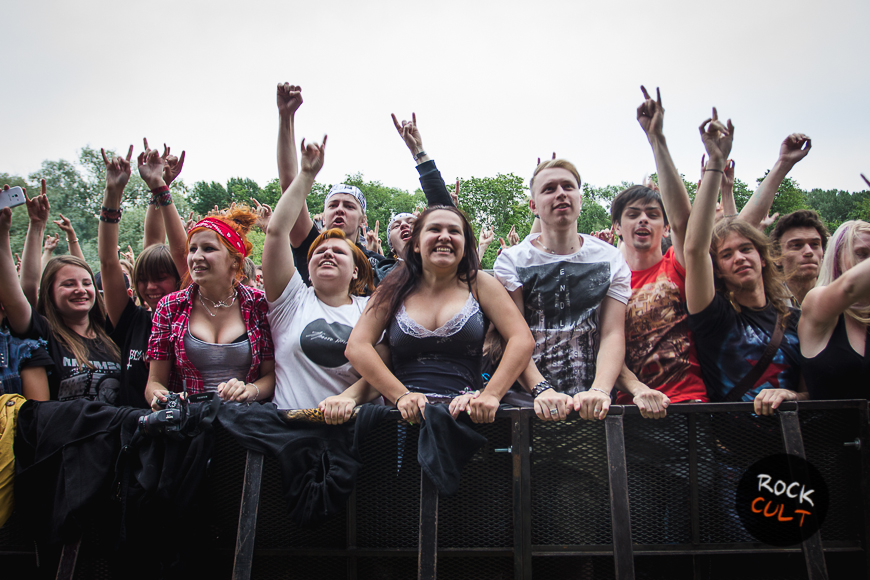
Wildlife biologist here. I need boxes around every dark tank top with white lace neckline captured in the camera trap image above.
[389,293,488,396]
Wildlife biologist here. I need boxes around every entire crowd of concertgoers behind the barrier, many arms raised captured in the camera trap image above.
[0,83,870,423]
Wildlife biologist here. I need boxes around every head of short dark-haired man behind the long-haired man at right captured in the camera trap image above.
[770,209,828,307]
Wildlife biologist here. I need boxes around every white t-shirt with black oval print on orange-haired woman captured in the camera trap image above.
[268,270,368,409]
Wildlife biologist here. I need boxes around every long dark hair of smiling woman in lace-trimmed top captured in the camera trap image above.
[371,205,480,318]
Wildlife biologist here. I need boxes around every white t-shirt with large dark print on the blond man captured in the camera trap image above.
[493,234,631,395]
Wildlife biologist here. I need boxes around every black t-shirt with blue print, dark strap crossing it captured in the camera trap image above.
[689,292,801,402]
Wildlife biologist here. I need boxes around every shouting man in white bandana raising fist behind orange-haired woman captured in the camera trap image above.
[277,83,385,290]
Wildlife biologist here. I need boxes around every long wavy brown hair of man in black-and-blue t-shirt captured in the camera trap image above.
[710,218,790,327]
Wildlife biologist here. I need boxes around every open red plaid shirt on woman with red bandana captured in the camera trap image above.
[145,284,275,395]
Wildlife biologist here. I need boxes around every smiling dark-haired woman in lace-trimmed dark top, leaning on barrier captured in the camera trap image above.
[347,206,534,423]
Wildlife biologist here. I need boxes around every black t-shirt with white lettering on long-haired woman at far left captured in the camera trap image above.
[27,312,121,405]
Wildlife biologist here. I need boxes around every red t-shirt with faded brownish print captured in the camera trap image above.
[616,247,709,405]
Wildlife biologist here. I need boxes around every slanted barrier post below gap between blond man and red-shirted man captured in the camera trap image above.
[604,407,634,580]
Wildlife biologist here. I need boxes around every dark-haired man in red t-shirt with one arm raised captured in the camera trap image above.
[610,89,709,418]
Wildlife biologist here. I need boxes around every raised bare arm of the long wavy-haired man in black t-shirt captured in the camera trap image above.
[683,108,734,314]
